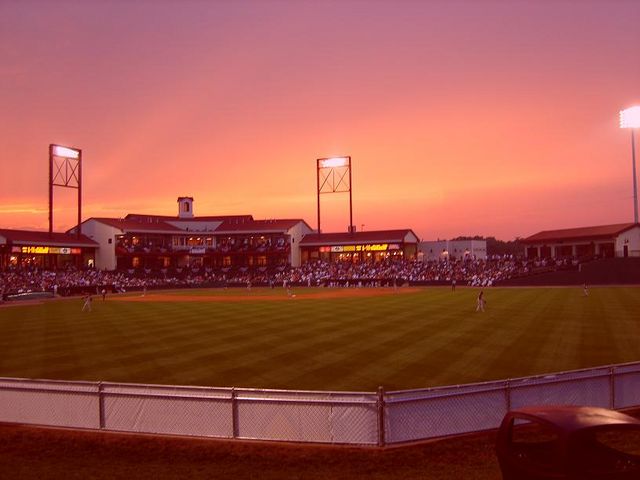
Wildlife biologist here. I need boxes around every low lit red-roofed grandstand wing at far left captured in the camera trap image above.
[0,229,99,270]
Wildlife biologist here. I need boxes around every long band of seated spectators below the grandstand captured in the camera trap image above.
[0,257,572,297]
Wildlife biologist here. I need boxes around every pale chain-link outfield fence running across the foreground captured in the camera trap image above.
[0,362,640,446]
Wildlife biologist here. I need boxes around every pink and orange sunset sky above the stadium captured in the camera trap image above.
[0,0,640,240]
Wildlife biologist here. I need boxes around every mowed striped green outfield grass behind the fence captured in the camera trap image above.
[0,287,640,391]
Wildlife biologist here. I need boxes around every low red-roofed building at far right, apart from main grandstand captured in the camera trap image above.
[522,223,640,258]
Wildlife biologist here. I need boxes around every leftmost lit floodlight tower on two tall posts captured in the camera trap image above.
[49,144,82,238]
